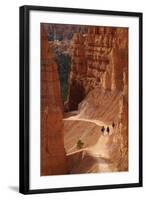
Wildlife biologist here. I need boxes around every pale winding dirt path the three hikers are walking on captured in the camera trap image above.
[64,115,117,173]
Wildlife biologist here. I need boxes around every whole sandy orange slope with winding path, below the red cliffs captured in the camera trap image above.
[64,88,122,173]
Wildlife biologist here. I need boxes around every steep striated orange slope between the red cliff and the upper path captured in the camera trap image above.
[79,87,122,124]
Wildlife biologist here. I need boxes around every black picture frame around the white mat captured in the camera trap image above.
[19,5,143,194]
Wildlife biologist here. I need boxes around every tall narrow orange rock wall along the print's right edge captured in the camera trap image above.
[111,28,128,171]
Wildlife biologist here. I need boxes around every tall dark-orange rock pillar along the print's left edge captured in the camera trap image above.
[41,25,67,175]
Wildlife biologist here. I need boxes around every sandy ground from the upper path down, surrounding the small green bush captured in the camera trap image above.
[64,113,117,173]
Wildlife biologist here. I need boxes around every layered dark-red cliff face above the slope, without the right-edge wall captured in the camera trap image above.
[68,27,116,110]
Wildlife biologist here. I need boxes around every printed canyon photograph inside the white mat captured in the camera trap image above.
[41,24,128,175]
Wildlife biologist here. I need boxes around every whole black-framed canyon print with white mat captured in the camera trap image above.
[20,6,142,194]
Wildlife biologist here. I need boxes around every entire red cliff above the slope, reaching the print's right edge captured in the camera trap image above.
[68,27,128,110]
